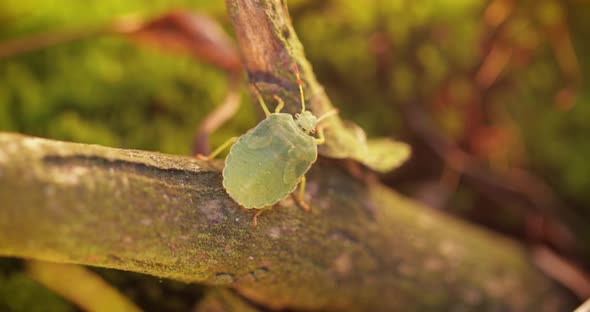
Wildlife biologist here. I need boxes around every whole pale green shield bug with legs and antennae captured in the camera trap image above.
[201,65,337,226]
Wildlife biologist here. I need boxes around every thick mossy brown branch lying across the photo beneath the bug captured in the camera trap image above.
[0,133,570,311]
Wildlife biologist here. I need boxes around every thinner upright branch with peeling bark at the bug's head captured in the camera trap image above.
[227,0,380,161]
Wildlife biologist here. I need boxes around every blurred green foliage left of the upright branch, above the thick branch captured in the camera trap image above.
[0,0,255,154]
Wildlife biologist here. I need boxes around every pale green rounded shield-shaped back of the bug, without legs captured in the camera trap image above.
[223,114,317,208]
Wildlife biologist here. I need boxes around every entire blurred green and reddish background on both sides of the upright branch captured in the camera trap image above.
[0,0,590,311]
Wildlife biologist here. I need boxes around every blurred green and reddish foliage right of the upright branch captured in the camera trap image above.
[290,0,590,244]
